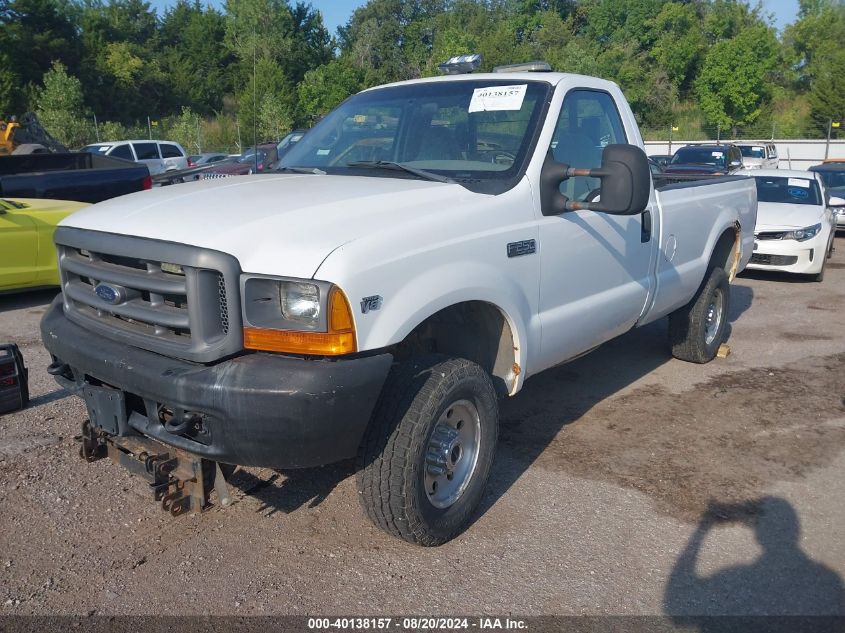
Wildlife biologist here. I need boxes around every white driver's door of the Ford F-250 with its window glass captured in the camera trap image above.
[539,89,656,367]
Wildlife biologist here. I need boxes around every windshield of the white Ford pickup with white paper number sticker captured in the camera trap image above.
[280,79,551,188]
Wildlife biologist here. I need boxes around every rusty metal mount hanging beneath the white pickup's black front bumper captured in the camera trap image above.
[79,420,232,516]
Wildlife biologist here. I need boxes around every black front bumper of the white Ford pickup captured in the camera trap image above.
[41,297,392,468]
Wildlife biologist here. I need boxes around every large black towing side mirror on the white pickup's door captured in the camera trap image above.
[540,145,651,215]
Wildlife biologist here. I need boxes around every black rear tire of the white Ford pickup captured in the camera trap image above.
[669,268,731,363]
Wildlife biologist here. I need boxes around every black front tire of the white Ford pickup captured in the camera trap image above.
[357,354,499,546]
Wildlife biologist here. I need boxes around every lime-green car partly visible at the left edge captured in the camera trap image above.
[0,198,90,292]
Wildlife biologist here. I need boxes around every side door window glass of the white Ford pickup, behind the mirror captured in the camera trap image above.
[552,90,628,201]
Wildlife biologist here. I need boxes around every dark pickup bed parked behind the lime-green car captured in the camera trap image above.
[0,152,153,202]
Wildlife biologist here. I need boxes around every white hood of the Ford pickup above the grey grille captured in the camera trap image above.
[61,174,474,278]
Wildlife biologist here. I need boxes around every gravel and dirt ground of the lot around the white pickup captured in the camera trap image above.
[0,237,845,615]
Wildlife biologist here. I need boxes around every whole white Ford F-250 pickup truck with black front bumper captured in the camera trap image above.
[41,72,757,545]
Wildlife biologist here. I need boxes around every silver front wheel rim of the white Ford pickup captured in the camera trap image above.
[424,400,481,509]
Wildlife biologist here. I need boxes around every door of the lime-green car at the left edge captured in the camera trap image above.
[0,200,38,290]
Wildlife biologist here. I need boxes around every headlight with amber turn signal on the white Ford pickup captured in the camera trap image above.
[241,274,357,356]
